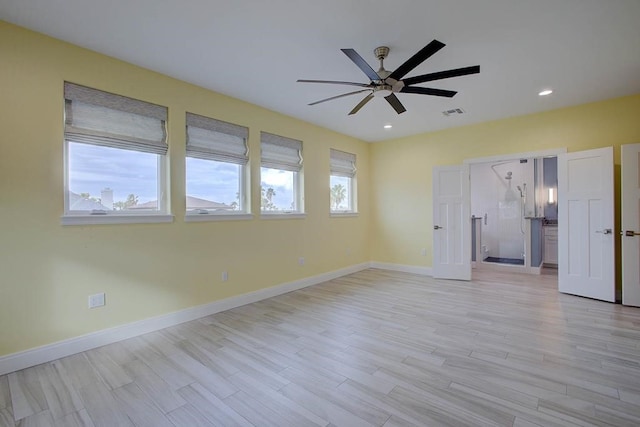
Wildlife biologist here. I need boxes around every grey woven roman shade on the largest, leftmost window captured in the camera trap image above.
[64,82,168,155]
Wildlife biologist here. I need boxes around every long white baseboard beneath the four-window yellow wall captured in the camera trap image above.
[0,262,370,375]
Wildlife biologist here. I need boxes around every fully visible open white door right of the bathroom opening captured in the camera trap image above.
[558,147,616,302]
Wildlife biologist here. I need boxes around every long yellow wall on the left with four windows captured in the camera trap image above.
[0,22,370,356]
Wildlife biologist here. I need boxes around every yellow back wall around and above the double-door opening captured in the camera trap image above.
[371,95,640,266]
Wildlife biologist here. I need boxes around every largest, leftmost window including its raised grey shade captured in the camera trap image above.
[63,82,172,224]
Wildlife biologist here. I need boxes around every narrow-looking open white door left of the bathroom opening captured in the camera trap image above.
[433,165,471,280]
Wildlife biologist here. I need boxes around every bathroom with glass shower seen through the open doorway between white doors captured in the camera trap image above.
[470,157,558,274]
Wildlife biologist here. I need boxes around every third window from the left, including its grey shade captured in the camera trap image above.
[260,132,304,213]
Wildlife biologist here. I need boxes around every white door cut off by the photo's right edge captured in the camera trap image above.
[621,144,640,307]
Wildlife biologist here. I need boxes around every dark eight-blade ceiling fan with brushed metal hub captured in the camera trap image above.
[298,40,480,115]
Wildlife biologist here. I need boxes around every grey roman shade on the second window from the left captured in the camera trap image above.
[187,113,249,165]
